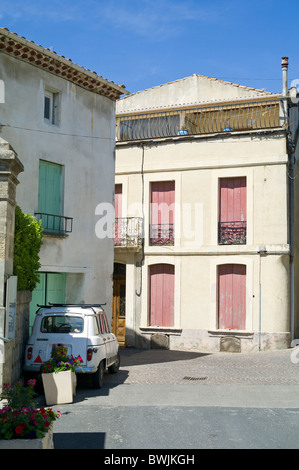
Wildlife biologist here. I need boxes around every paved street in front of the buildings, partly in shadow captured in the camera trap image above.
[45,349,299,452]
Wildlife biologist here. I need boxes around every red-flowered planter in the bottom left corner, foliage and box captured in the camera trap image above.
[0,379,61,449]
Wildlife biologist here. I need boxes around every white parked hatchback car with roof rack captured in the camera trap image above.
[23,304,120,388]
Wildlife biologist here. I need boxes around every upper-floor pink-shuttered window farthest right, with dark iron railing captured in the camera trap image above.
[218,177,247,245]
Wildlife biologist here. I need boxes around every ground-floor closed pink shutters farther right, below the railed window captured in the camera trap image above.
[218,264,246,330]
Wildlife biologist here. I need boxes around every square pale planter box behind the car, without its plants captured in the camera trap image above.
[42,370,77,405]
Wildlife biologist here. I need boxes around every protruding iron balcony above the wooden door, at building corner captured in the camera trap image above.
[114,217,143,250]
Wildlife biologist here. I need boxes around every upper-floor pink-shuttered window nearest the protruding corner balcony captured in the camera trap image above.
[150,181,175,245]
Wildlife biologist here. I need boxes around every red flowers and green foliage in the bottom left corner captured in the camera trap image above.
[0,379,61,439]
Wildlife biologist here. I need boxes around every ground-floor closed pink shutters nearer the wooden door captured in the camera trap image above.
[150,264,174,326]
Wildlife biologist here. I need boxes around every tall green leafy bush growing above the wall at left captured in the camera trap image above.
[14,206,43,291]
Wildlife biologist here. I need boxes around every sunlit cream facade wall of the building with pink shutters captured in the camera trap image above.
[116,132,290,350]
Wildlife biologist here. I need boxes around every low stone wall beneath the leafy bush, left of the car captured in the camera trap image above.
[3,291,32,383]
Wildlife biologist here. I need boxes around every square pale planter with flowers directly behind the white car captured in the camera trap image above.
[40,347,82,405]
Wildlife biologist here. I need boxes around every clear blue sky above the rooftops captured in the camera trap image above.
[0,0,299,97]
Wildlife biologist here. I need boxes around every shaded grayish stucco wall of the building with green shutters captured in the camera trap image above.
[0,53,115,319]
